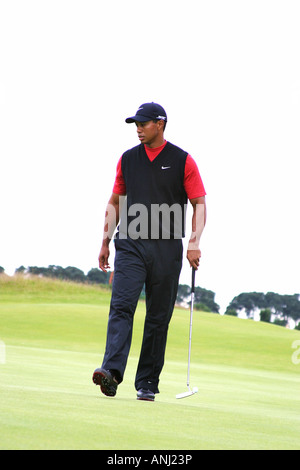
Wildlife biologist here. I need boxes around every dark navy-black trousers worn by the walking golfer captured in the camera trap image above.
[102,237,182,393]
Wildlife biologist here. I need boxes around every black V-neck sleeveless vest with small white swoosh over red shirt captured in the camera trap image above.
[119,142,188,239]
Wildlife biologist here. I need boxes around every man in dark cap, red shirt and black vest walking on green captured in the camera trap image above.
[93,103,206,401]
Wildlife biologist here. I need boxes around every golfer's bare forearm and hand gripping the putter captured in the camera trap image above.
[186,196,206,270]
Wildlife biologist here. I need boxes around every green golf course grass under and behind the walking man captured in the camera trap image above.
[0,276,300,450]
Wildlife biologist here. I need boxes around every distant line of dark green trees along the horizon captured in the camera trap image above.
[0,265,300,330]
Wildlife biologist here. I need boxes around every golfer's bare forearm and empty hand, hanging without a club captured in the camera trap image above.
[98,193,121,273]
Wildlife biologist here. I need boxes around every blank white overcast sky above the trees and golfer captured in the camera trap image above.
[0,0,300,312]
